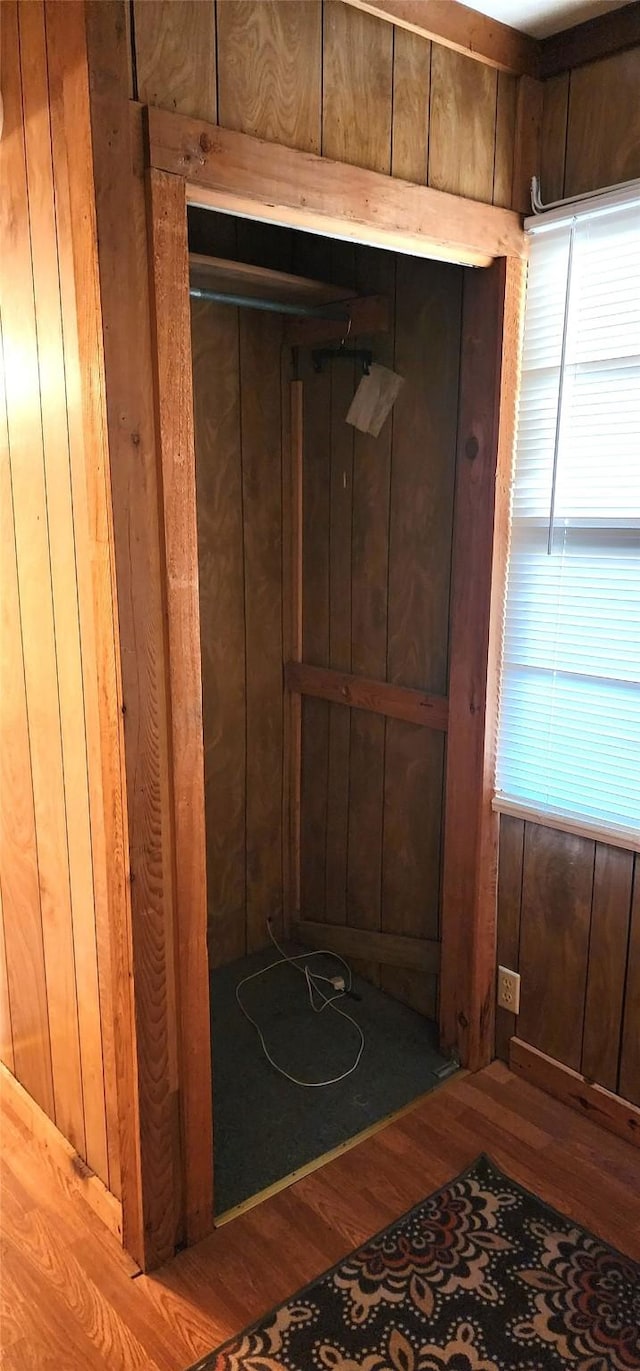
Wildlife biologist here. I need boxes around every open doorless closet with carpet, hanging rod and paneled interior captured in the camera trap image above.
[188,206,465,1222]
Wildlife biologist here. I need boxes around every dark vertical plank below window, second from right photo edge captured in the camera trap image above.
[580,843,640,1093]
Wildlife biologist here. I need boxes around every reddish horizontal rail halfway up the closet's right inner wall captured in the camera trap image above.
[285,662,448,733]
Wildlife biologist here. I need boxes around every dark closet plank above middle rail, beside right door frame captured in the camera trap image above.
[388,256,462,695]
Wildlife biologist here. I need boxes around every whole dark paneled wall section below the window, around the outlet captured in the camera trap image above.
[497,814,640,1104]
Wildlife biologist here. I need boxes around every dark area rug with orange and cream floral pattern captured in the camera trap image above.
[192,1157,640,1371]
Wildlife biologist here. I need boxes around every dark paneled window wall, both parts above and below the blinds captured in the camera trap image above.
[496,48,640,1104]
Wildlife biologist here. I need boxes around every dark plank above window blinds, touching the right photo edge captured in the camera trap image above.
[565,48,640,195]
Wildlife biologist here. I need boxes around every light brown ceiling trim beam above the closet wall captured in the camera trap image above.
[335,0,540,77]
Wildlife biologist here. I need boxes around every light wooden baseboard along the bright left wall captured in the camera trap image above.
[0,1063,122,1243]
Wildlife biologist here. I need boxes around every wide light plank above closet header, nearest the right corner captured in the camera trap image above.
[429,44,497,204]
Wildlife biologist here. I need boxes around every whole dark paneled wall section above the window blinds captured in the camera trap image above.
[541,48,640,202]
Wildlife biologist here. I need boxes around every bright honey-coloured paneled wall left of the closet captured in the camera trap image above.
[0,0,126,1196]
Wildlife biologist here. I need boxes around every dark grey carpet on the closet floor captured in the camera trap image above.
[211,945,448,1213]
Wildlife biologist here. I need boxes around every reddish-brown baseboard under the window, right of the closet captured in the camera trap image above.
[508,1038,640,1148]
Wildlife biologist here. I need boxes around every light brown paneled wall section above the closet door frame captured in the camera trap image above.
[132,0,517,206]
